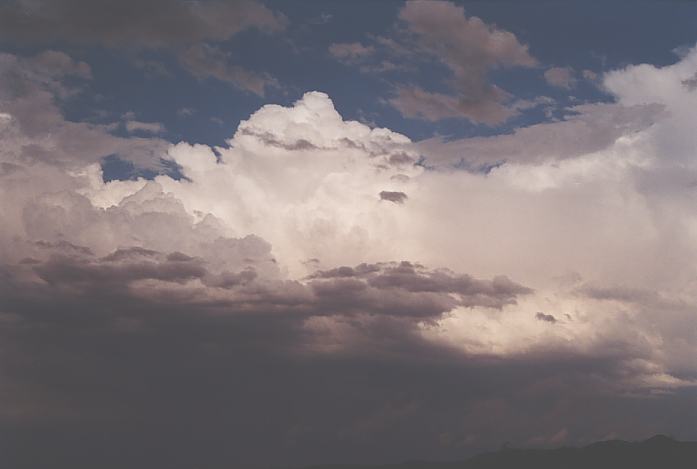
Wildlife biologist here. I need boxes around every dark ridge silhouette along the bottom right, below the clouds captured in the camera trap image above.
[304,435,697,469]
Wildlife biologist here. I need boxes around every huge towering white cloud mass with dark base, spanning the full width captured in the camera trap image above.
[0,46,697,468]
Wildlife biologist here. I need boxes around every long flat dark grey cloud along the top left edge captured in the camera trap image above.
[0,0,286,49]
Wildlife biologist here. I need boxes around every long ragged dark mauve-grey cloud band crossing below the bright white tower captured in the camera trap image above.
[12,249,532,327]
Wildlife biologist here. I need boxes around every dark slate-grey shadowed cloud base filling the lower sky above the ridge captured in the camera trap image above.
[0,249,697,469]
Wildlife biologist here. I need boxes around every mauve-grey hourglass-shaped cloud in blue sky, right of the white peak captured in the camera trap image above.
[390,1,537,125]
